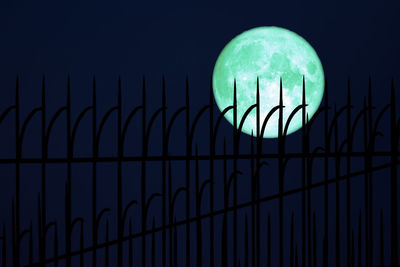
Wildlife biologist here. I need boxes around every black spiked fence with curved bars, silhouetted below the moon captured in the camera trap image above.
[0,78,400,267]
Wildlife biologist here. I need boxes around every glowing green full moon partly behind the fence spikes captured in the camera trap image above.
[212,26,325,138]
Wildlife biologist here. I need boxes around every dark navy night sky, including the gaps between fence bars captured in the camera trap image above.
[0,0,400,266]
